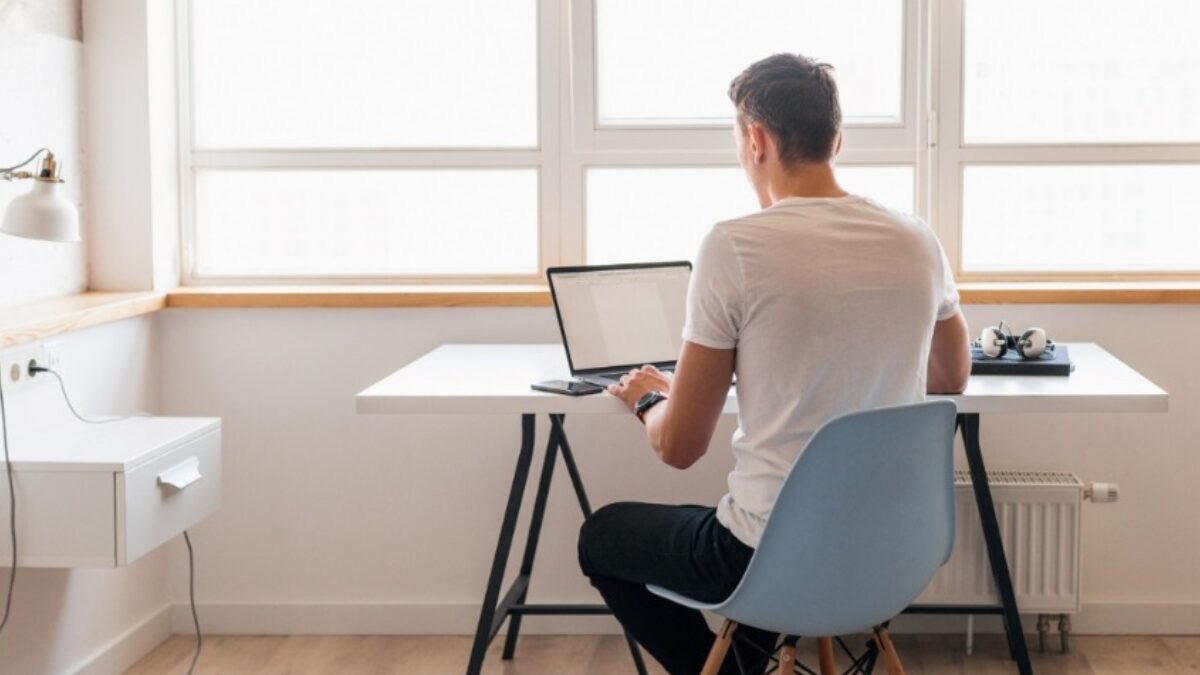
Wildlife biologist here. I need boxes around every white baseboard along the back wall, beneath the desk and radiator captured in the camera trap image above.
[170,601,1200,635]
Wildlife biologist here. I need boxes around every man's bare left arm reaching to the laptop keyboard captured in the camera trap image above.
[608,341,734,468]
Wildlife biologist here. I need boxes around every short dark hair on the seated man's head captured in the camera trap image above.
[730,54,841,167]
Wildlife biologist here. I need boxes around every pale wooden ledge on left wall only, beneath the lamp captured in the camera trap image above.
[0,292,167,348]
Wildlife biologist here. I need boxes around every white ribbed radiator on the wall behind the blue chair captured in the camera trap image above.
[914,471,1085,614]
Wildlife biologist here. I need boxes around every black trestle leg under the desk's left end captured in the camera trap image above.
[467,414,646,675]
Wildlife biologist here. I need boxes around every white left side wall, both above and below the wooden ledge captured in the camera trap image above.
[0,0,169,675]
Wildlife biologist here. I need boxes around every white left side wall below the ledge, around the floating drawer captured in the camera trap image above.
[0,316,169,675]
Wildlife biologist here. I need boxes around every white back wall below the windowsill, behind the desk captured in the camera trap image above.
[162,306,1200,633]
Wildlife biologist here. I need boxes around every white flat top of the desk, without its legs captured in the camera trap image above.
[356,342,1166,414]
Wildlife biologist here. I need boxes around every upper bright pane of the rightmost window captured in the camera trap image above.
[962,0,1200,143]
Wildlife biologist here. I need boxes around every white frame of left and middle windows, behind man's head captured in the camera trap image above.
[176,0,934,286]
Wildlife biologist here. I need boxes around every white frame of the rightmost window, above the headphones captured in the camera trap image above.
[930,0,1200,282]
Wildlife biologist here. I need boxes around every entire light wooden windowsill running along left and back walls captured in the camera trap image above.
[0,281,1200,348]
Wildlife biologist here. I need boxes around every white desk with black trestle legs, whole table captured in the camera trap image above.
[358,342,1166,675]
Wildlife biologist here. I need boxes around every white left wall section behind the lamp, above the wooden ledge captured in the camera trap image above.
[0,0,88,306]
